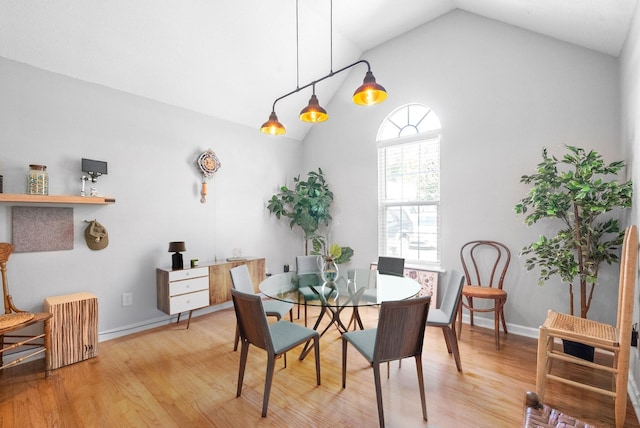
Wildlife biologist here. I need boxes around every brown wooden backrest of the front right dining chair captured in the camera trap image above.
[373,296,431,363]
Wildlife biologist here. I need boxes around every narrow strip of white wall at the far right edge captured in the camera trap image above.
[620,0,640,408]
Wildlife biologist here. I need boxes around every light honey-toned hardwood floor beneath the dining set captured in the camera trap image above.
[0,308,639,428]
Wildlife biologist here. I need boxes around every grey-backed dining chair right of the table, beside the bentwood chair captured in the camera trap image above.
[427,270,464,372]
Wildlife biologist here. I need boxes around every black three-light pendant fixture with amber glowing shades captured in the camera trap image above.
[260,0,387,135]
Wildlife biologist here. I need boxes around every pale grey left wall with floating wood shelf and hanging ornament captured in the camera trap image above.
[0,58,301,337]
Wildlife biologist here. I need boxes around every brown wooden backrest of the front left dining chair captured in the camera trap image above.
[231,289,273,353]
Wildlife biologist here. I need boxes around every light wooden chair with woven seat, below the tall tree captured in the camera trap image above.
[536,225,638,428]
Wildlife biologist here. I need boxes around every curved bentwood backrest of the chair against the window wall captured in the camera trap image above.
[460,240,511,290]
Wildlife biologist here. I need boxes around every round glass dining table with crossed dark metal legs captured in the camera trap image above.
[259,269,420,359]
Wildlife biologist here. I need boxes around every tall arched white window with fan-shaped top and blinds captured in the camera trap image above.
[377,104,440,263]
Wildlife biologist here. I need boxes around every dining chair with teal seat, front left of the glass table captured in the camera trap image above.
[231,290,320,418]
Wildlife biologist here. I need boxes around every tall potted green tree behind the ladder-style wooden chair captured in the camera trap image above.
[515,146,632,318]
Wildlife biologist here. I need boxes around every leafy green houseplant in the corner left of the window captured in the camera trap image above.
[267,168,353,263]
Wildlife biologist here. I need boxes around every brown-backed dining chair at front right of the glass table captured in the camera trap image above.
[342,296,431,427]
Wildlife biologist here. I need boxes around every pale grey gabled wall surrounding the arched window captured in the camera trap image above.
[304,11,620,333]
